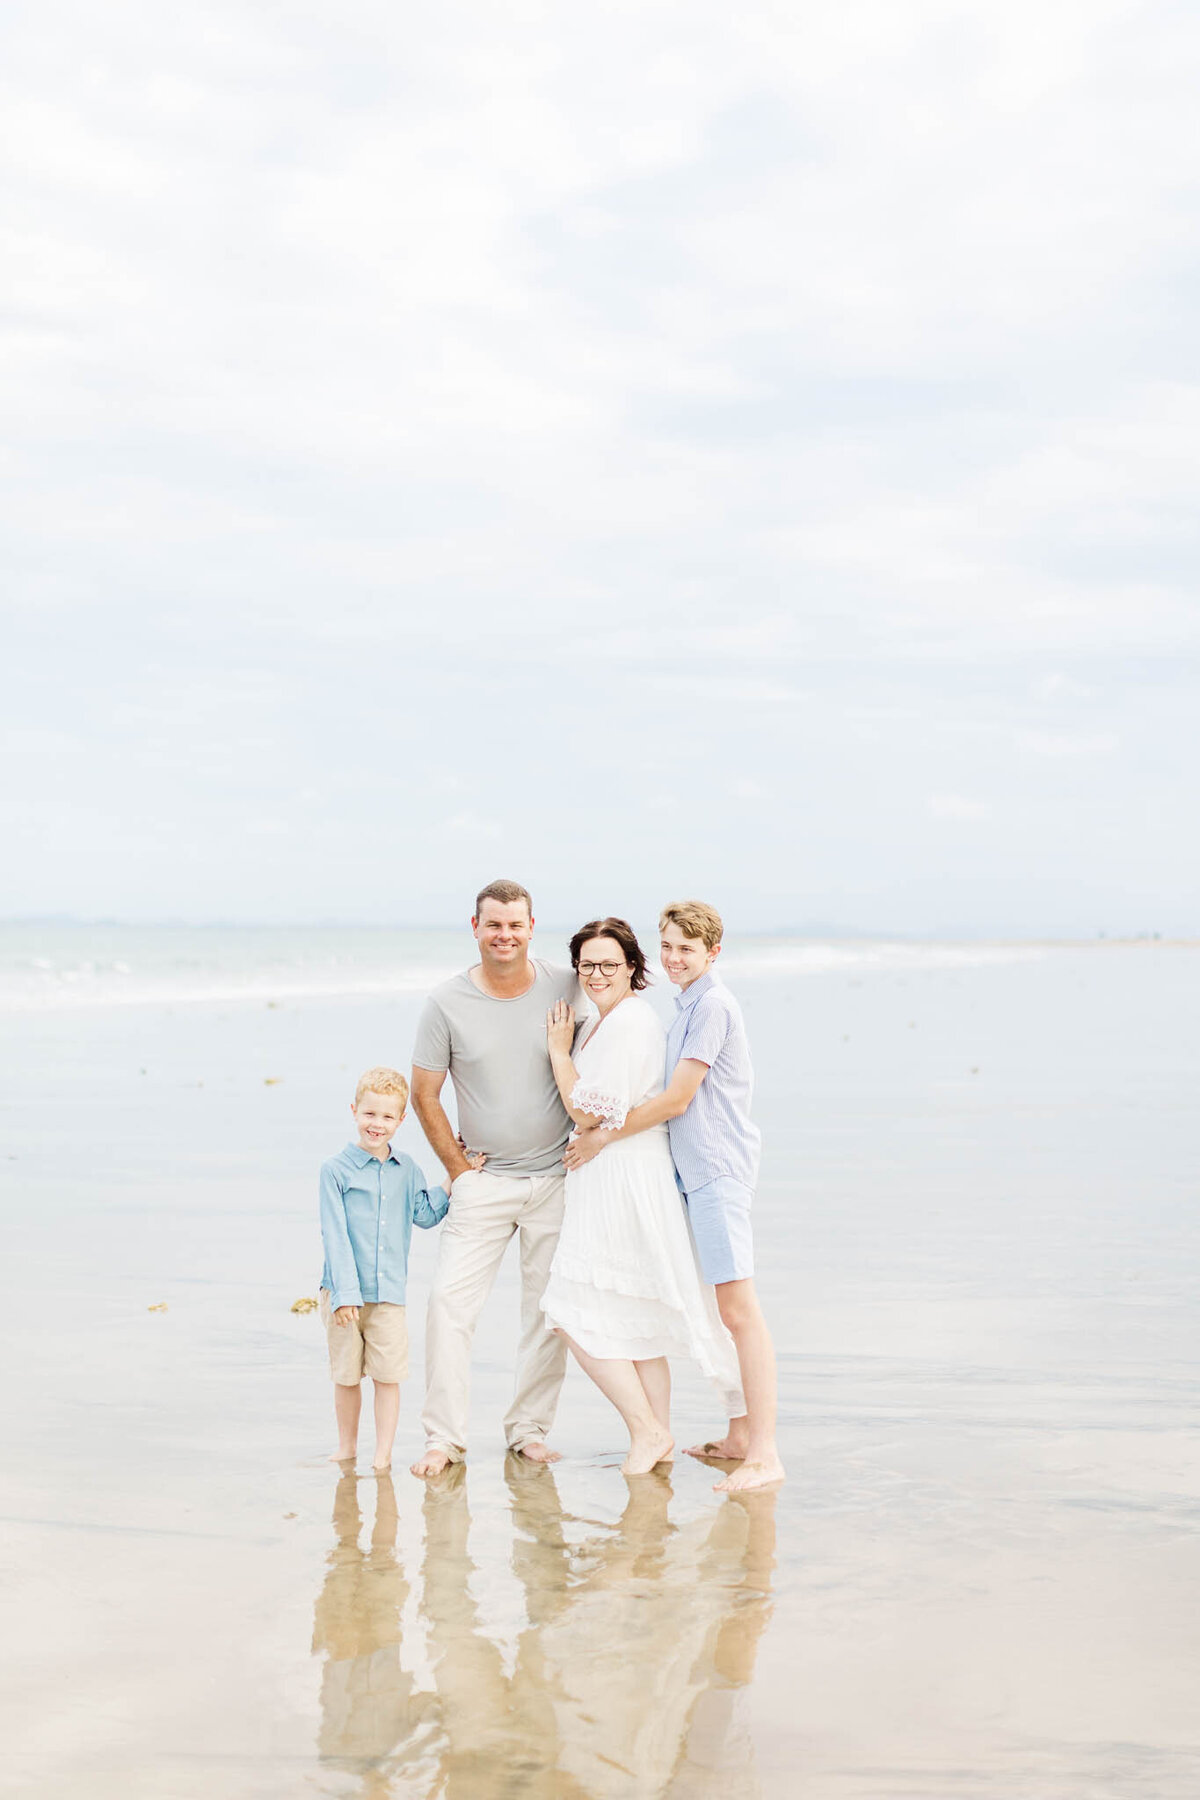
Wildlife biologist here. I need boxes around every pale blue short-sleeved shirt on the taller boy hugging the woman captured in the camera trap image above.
[667,970,763,1193]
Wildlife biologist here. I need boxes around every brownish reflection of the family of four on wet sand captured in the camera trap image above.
[313,1458,775,1800]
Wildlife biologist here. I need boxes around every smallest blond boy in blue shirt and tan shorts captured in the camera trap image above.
[320,1069,464,1474]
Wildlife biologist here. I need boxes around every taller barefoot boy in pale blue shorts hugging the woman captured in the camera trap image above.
[563,900,784,1494]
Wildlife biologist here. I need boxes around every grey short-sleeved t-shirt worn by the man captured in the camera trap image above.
[412,956,579,1175]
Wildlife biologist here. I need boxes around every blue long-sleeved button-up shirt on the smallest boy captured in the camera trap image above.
[320,1143,450,1310]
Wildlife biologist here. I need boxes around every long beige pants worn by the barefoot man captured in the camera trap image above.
[421,1168,567,1462]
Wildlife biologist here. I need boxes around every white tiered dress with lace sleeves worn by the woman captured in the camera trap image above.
[542,994,745,1418]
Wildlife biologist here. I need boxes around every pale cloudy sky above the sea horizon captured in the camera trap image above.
[0,0,1200,936]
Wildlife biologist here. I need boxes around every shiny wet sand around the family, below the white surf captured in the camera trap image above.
[0,947,1200,1800]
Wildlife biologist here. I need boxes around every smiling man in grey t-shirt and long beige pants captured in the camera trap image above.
[412,882,576,1478]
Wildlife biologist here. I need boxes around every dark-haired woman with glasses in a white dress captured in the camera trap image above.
[542,918,741,1474]
